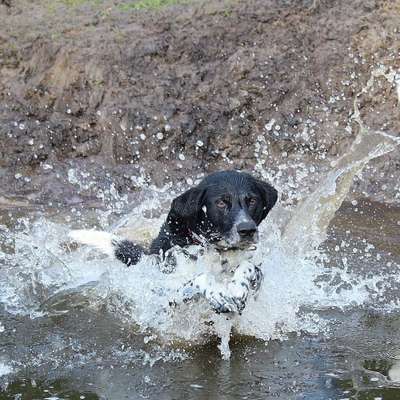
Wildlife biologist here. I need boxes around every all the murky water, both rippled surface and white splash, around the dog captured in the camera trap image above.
[0,124,400,399]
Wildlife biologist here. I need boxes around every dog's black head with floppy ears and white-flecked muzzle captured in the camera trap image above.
[170,171,278,249]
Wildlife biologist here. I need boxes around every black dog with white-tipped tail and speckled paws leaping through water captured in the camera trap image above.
[71,171,278,312]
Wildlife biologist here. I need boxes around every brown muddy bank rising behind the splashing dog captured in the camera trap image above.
[0,0,400,204]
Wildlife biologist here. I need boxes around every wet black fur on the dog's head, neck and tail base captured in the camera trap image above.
[115,171,278,265]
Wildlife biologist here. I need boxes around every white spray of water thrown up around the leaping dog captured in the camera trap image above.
[0,67,400,358]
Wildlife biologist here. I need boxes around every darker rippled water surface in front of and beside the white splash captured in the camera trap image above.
[0,202,400,399]
